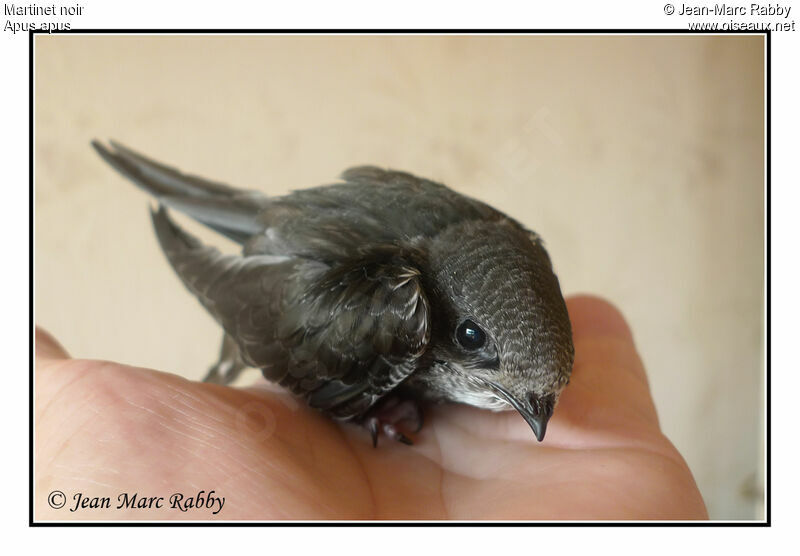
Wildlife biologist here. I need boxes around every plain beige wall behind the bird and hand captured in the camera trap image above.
[34,35,764,519]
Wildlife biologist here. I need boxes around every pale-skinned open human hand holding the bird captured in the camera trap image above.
[34,297,708,520]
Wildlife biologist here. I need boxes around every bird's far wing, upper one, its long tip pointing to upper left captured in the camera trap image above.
[92,141,506,263]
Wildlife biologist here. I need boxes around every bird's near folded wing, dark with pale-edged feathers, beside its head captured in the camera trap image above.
[153,207,430,419]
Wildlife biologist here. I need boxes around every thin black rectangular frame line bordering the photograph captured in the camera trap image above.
[28,28,772,527]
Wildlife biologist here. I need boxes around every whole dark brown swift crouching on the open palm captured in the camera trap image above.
[92,140,574,446]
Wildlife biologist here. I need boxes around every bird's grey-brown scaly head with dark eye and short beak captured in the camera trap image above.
[429,221,574,441]
